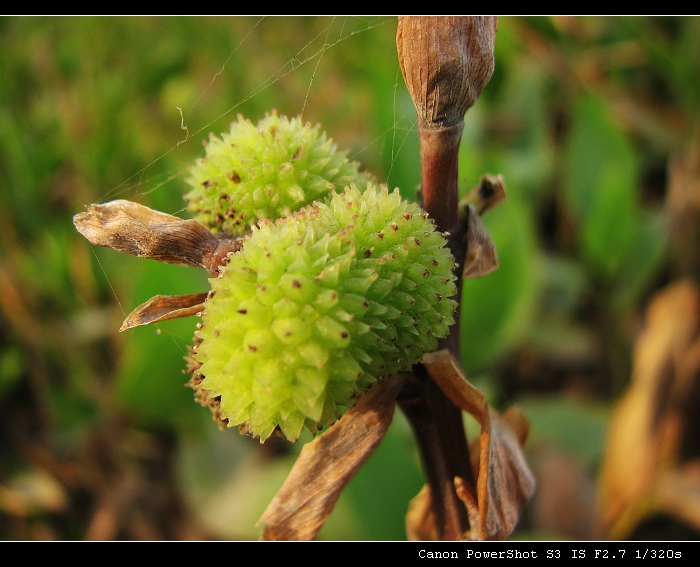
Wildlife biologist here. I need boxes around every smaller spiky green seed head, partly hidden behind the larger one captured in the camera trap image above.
[185,112,371,235]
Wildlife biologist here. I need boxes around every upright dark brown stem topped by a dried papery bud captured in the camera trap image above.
[396,16,497,539]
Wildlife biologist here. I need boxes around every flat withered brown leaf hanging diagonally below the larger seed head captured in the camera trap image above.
[259,376,405,541]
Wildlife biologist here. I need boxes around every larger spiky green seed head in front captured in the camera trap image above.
[194,183,456,441]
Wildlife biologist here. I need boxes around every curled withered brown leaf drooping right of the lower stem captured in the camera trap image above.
[420,350,536,541]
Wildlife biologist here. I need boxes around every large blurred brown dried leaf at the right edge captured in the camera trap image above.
[599,280,700,539]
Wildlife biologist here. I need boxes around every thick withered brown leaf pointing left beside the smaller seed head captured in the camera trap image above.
[73,199,240,273]
